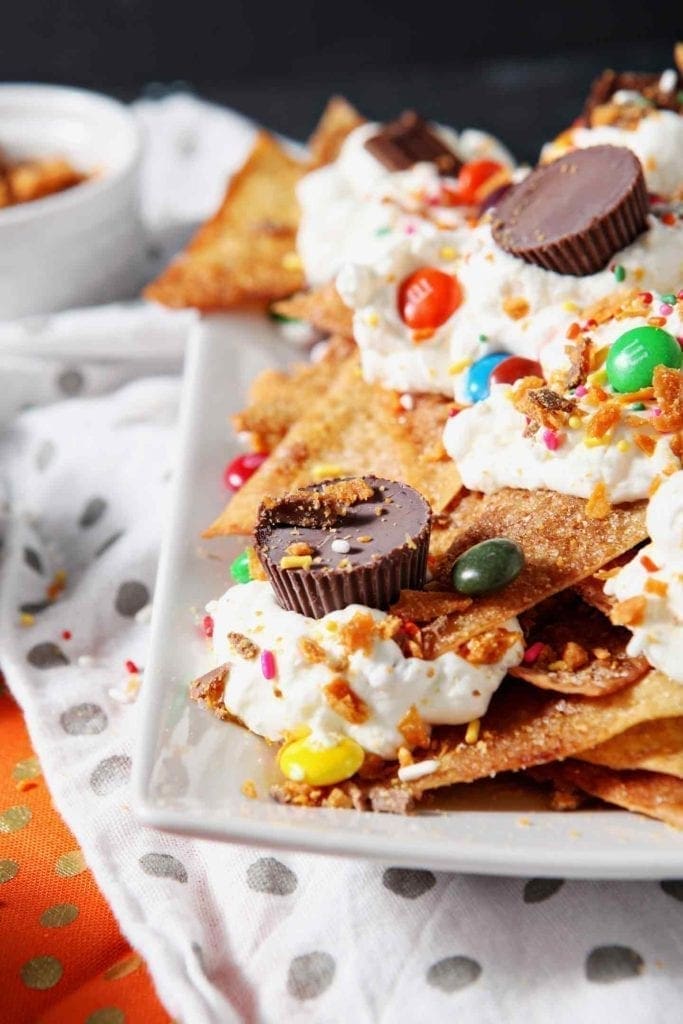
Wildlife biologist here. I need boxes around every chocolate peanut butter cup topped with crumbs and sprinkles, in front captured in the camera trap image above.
[256,476,431,618]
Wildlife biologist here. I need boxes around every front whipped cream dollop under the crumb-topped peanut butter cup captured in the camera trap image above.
[207,581,523,759]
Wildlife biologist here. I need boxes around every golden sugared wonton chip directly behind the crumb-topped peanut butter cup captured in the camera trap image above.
[205,357,460,537]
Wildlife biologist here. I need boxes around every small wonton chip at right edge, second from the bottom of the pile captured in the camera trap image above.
[581,718,683,778]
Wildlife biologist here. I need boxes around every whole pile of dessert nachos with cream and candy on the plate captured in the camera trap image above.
[146,45,683,827]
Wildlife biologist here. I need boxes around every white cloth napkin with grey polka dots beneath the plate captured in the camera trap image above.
[0,96,683,1024]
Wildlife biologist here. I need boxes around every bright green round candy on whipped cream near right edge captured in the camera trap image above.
[606,327,683,392]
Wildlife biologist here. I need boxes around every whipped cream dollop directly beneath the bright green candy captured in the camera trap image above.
[443,376,680,504]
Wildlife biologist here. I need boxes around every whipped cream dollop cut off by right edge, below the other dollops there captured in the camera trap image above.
[604,472,683,683]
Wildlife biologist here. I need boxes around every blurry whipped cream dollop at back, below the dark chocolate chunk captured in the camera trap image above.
[297,123,513,285]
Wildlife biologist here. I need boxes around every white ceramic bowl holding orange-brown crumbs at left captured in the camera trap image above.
[0,84,144,318]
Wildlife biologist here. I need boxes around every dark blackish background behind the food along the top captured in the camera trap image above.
[0,0,683,159]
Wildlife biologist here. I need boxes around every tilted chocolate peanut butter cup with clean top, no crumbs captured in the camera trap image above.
[493,145,648,278]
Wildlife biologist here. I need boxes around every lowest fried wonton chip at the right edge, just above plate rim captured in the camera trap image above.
[532,761,683,828]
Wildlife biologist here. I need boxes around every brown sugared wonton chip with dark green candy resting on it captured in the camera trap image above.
[423,488,647,655]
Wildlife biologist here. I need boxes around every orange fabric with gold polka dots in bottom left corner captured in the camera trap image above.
[0,675,170,1024]
